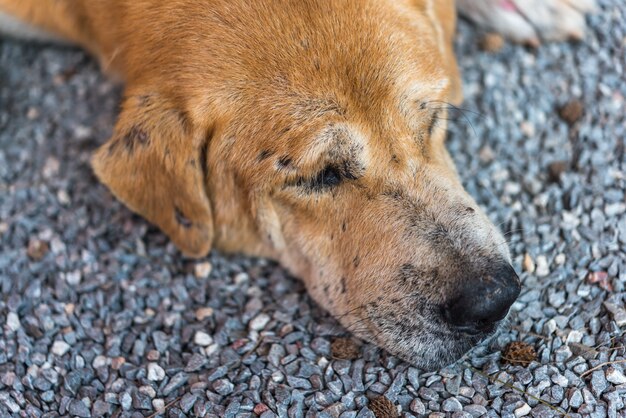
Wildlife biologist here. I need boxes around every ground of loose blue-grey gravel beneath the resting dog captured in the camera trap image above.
[0,0,626,418]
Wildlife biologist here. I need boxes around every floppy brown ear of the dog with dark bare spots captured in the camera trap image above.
[92,90,213,257]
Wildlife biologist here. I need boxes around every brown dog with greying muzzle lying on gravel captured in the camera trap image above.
[0,0,592,368]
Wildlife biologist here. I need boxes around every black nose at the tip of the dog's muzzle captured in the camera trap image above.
[443,263,521,332]
